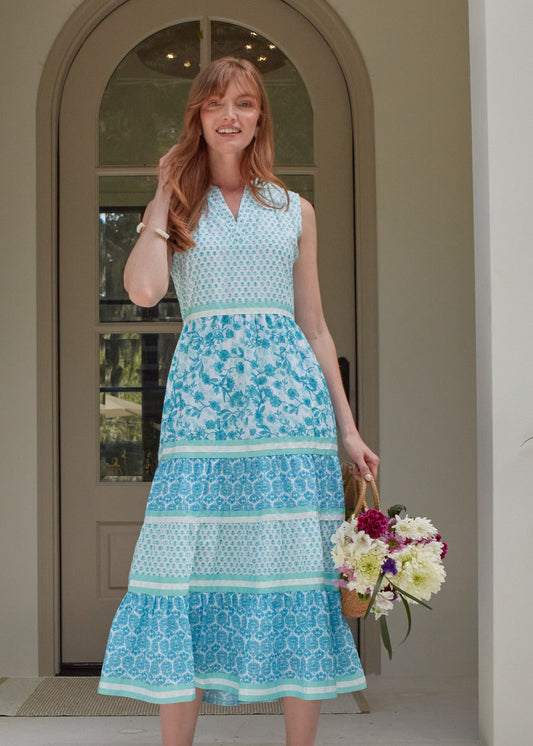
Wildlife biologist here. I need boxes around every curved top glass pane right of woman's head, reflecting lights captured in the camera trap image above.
[211,21,313,164]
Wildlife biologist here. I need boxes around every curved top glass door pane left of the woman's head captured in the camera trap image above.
[100,21,201,166]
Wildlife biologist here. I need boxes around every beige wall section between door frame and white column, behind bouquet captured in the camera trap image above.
[329,0,477,675]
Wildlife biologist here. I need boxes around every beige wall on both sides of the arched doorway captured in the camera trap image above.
[0,0,476,676]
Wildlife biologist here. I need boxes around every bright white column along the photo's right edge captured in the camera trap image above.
[470,0,533,746]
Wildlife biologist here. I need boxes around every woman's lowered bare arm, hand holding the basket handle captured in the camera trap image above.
[294,197,379,479]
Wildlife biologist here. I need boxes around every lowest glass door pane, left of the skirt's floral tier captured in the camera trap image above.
[100,334,178,482]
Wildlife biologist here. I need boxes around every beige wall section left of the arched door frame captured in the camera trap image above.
[0,0,84,676]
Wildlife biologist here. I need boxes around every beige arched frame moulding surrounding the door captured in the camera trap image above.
[37,0,380,676]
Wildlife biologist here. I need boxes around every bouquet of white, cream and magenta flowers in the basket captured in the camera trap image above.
[331,485,447,658]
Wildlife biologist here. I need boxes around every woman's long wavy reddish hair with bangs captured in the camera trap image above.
[168,57,289,251]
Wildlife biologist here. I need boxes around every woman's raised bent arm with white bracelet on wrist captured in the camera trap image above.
[124,146,175,307]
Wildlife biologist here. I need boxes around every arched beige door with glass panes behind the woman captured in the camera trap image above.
[59,0,355,663]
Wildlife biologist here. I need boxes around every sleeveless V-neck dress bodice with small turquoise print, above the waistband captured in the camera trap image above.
[171,184,302,321]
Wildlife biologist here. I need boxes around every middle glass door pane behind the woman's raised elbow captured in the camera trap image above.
[99,176,181,322]
